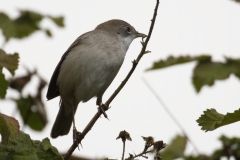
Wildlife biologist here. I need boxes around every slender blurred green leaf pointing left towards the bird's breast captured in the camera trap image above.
[147,55,211,71]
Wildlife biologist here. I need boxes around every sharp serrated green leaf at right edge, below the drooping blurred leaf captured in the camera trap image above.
[197,109,240,132]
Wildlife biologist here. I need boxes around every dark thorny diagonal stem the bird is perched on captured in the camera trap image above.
[64,0,159,160]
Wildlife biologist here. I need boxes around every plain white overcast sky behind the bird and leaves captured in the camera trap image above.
[0,0,240,159]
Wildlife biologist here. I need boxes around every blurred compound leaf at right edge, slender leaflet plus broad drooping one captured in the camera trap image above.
[147,55,240,92]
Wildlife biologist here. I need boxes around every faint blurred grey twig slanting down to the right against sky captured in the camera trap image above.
[142,77,199,155]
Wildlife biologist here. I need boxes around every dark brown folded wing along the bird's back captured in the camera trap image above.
[47,36,81,100]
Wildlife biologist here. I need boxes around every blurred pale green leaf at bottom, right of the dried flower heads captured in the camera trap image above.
[160,135,187,160]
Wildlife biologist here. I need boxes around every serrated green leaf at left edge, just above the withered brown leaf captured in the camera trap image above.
[0,49,19,75]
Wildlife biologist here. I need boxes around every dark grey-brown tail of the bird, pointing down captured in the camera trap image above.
[51,103,77,138]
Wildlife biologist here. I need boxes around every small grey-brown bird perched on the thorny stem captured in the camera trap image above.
[47,19,146,138]
